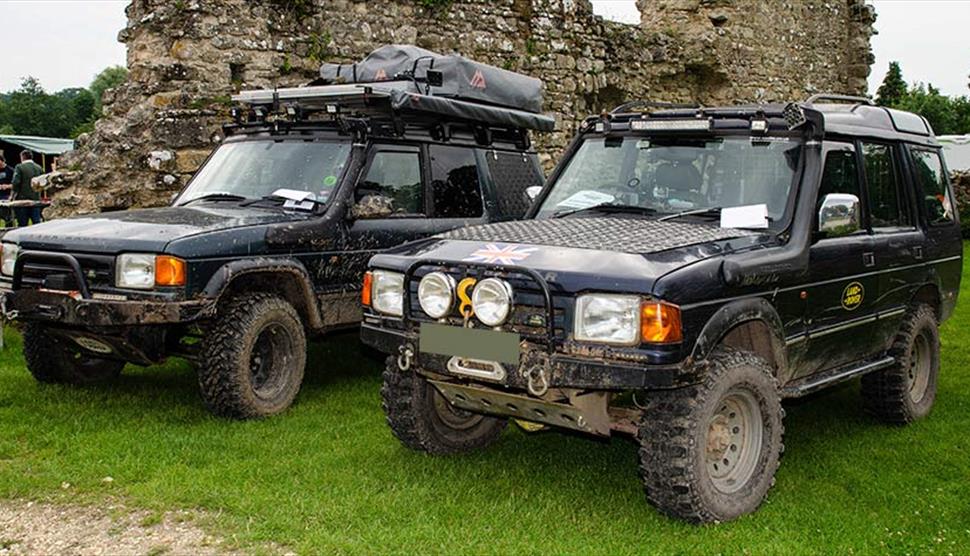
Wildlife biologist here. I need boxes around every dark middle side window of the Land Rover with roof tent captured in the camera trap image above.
[430,145,483,218]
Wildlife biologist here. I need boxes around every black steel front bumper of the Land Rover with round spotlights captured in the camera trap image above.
[361,322,699,391]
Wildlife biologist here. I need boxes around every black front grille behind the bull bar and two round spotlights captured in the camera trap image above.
[408,265,572,343]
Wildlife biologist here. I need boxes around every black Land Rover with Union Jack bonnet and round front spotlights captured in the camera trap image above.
[362,96,962,522]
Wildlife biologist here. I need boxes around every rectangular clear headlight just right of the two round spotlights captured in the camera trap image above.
[573,294,640,346]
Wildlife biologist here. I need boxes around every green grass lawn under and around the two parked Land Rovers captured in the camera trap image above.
[0,266,970,554]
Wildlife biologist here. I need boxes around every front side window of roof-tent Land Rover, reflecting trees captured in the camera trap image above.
[355,149,424,217]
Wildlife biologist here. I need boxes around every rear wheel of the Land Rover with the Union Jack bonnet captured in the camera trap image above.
[862,304,940,425]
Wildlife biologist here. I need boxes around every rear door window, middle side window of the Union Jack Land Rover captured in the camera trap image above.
[862,143,910,229]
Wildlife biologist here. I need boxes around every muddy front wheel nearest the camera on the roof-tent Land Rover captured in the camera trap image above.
[198,293,307,419]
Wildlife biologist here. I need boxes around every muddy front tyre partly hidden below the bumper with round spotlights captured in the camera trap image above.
[381,356,508,455]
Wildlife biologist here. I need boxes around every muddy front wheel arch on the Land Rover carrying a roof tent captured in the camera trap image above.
[203,258,323,330]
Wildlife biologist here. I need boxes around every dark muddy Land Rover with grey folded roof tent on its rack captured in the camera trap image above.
[0,47,554,418]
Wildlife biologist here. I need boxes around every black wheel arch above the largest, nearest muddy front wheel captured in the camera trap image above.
[691,297,788,379]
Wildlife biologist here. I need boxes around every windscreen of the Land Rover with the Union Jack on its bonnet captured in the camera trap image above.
[537,136,801,227]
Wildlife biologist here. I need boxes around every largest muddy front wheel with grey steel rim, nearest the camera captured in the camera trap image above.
[639,349,784,523]
